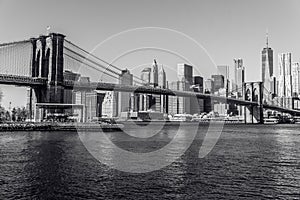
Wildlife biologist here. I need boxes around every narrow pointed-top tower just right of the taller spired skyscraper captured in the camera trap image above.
[156,65,168,113]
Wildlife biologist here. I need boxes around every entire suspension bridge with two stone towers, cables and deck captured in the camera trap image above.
[0,33,300,123]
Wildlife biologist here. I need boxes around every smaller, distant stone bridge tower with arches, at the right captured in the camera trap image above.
[244,82,264,124]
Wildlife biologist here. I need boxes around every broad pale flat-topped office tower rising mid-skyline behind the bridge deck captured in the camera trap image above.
[177,64,194,114]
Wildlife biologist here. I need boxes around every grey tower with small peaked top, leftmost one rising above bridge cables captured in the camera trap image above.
[118,69,133,115]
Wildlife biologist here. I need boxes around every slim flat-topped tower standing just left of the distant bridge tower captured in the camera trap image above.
[233,58,245,97]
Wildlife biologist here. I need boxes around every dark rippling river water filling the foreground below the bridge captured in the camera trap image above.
[0,125,300,200]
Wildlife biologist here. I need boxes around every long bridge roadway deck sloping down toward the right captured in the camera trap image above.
[0,74,300,115]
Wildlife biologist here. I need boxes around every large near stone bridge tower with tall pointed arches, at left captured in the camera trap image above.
[31,33,65,103]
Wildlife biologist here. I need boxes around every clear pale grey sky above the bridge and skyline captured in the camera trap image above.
[0,0,300,107]
